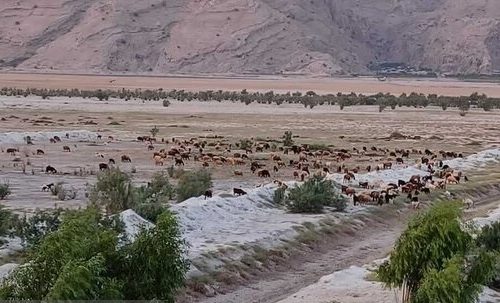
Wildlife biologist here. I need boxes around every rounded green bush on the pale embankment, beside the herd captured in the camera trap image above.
[285,176,347,213]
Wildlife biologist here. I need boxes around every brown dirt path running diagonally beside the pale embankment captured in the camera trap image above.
[190,188,500,303]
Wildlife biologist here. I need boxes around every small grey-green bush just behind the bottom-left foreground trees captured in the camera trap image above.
[14,208,62,247]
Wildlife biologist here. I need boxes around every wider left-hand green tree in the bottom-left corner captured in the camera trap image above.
[0,209,119,300]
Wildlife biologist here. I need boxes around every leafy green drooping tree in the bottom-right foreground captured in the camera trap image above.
[378,202,495,303]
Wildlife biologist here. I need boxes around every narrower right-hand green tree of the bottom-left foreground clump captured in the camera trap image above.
[125,211,189,302]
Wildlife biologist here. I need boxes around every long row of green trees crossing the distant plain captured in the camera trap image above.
[0,88,500,111]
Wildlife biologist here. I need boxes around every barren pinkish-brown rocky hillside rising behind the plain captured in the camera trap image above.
[0,0,500,75]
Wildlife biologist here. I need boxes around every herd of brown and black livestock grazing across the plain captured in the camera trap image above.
[2,135,467,207]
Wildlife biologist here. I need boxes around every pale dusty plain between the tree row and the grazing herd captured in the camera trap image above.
[0,97,500,209]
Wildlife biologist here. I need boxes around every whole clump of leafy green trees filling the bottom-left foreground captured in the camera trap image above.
[0,208,187,302]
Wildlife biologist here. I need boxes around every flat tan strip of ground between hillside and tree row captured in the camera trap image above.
[0,73,500,97]
